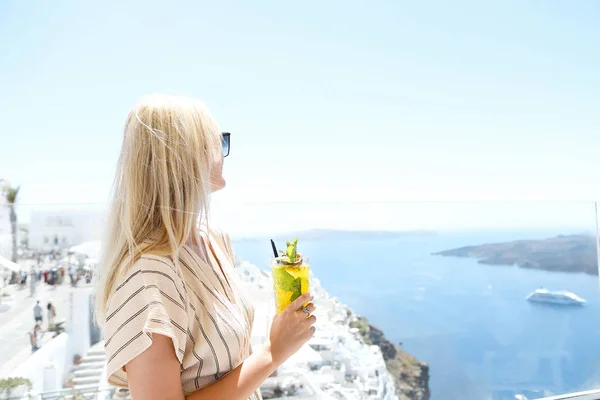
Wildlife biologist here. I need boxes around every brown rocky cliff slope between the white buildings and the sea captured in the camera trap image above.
[351,317,430,400]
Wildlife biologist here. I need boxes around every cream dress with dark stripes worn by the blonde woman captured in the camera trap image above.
[104,231,261,400]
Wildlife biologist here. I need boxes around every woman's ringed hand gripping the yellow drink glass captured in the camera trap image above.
[267,293,317,365]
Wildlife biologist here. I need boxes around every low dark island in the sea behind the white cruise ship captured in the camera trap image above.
[433,235,598,275]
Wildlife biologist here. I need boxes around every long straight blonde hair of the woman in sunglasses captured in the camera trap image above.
[95,95,222,325]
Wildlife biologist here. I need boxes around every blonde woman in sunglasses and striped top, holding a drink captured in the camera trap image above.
[96,95,315,400]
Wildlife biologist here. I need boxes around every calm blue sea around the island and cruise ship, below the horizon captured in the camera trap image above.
[233,230,600,400]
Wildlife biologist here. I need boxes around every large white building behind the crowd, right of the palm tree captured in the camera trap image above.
[29,210,105,250]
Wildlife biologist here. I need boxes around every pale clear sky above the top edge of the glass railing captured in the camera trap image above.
[0,0,600,230]
